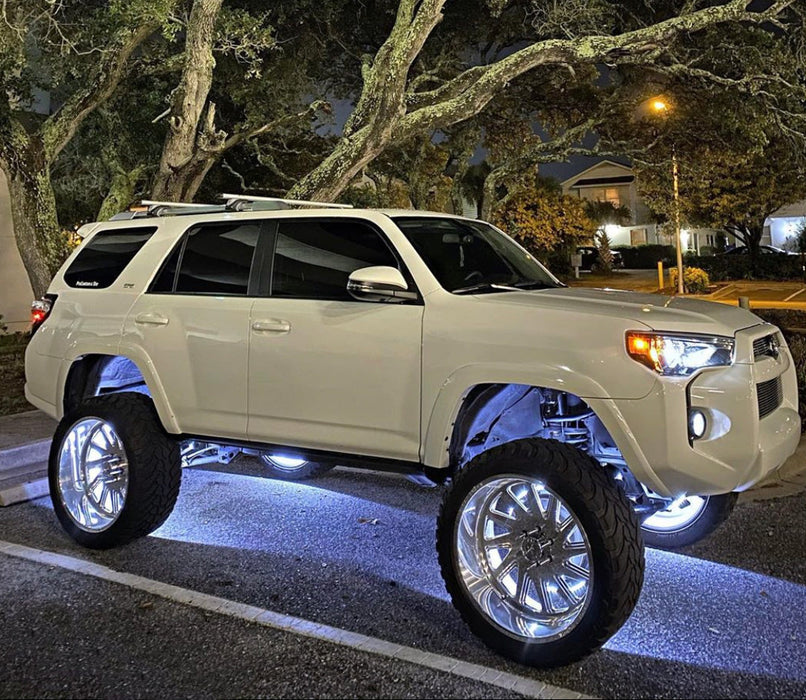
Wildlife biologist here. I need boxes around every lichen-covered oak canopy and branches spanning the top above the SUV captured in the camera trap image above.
[0,0,806,293]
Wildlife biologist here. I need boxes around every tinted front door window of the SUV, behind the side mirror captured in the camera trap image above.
[271,220,398,301]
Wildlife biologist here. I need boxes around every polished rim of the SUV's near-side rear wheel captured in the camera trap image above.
[59,418,129,532]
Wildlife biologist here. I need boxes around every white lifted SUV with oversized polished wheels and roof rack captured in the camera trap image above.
[26,197,800,666]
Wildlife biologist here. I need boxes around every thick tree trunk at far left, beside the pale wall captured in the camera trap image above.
[3,161,67,298]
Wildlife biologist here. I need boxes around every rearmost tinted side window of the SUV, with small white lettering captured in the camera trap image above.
[64,226,157,289]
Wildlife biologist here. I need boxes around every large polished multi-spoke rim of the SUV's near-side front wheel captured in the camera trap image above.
[456,475,592,641]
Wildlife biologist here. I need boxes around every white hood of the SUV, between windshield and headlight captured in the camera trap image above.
[475,287,763,336]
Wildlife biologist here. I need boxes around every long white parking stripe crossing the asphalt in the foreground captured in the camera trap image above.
[0,540,589,698]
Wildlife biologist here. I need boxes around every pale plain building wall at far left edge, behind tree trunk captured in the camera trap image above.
[0,171,34,331]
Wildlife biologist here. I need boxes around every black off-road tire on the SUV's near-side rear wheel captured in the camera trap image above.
[48,392,182,549]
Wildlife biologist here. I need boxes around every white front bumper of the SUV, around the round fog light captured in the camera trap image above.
[590,324,800,497]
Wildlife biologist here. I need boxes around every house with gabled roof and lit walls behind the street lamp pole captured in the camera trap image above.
[561,160,716,252]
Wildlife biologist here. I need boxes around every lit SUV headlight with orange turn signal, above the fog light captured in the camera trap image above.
[627,331,734,377]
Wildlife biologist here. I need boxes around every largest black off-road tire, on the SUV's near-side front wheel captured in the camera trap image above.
[437,438,644,668]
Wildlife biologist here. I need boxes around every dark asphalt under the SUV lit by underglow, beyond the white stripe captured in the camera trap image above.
[0,459,806,698]
